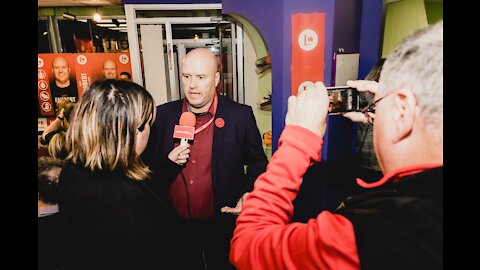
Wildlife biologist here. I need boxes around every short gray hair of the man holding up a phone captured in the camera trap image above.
[378,21,443,142]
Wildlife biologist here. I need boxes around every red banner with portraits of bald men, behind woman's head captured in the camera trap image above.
[38,52,132,116]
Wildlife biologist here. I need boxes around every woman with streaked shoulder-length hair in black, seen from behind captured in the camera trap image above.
[58,79,177,270]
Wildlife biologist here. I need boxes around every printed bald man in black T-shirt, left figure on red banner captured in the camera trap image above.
[50,55,78,113]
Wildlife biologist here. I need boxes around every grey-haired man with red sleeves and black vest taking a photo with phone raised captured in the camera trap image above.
[230,22,443,270]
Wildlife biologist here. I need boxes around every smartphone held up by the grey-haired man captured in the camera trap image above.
[327,86,360,114]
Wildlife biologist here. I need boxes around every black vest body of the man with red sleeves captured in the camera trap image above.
[338,167,443,269]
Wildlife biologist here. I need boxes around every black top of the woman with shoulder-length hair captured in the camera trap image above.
[59,161,181,269]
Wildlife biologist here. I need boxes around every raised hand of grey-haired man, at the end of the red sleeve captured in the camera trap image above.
[285,82,330,137]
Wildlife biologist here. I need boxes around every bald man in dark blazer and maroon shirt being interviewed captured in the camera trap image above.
[142,48,268,270]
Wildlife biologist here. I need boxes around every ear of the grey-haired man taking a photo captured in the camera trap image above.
[393,90,417,142]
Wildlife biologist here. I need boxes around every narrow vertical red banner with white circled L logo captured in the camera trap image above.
[291,13,325,95]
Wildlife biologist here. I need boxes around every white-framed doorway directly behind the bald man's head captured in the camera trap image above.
[125,4,245,105]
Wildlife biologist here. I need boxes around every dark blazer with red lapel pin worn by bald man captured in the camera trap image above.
[142,96,268,212]
